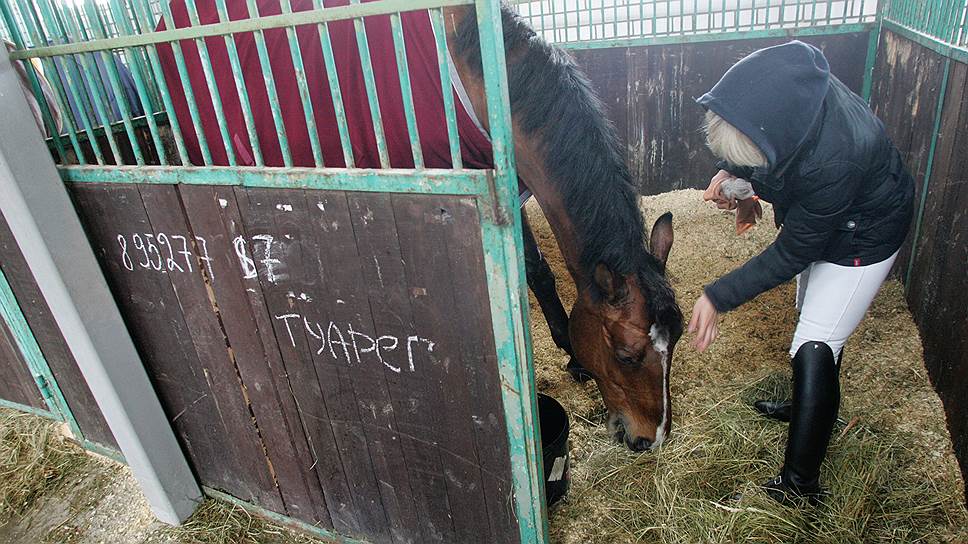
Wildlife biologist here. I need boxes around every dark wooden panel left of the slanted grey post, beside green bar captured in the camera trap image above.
[0,210,118,444]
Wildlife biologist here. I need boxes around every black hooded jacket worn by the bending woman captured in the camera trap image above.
[698,41,914,312]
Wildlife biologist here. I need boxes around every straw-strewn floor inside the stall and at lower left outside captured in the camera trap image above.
[0,190,968,544]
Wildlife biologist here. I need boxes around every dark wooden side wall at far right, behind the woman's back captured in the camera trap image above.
[872,30,968,498]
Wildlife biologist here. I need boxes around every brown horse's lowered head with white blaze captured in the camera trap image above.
[569,214,682,451]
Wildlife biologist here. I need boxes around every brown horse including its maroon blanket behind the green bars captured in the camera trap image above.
[158,0,682,451]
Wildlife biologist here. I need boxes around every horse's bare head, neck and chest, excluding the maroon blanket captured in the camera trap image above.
[445,6,682,451]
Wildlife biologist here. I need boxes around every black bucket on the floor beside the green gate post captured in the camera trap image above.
[538,393,571,508]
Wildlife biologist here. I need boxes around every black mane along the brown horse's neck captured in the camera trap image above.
[456,6,681,332]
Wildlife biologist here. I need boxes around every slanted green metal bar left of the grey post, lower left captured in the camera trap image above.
[0,270,83,438]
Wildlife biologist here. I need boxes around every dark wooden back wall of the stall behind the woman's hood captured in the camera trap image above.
[572,32,869,195]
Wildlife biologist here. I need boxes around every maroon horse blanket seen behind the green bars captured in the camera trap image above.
[158,0,491,168]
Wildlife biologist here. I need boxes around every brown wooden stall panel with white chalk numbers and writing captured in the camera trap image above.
[66,184,518,543]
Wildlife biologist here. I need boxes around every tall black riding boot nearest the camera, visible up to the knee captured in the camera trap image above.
[763,342,840,503]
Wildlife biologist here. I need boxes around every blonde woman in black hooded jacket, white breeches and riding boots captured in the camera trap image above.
[689,41,914,502]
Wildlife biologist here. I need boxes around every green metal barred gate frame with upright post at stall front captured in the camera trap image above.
[0,0,547,542]
